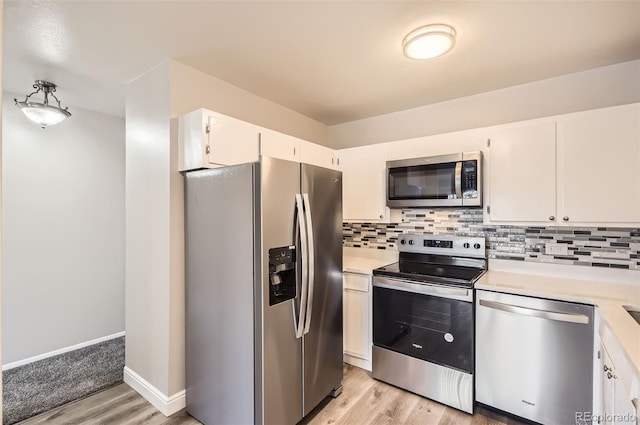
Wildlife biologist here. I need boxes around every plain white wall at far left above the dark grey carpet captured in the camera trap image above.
[2,93,124,364]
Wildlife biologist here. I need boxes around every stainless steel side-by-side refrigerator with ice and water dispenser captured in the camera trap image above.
[185,157,342,425]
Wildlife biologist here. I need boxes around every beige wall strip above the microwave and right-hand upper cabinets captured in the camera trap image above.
[327,60,640,149]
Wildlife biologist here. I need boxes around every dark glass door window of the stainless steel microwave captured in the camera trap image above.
[388,162,457,200]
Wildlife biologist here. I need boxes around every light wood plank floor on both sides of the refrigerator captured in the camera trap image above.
[19,364,522,425]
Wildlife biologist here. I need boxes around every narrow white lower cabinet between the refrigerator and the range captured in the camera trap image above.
[342,272,373,371]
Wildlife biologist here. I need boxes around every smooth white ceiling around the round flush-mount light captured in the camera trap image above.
[3,0,640,125]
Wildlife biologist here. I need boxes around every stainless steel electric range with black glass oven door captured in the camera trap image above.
[372,234,487,413]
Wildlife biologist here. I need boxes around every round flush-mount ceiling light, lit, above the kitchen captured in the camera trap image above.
[402,24,456,59]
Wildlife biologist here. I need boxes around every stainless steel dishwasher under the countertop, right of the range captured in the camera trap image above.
[475,290,594,425]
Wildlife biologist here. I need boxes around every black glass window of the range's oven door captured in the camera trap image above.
[373,287,473,373]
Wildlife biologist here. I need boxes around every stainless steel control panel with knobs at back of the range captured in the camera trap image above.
[398,233,486,258]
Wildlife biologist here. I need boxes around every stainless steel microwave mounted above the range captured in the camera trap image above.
[386,151,482,208]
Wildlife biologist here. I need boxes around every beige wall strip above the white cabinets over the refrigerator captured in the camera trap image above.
[170,61,327,145]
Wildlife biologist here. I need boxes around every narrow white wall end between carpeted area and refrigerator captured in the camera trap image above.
[125,62,175,396]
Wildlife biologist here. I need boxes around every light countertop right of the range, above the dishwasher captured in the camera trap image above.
[475,271,640,375]
